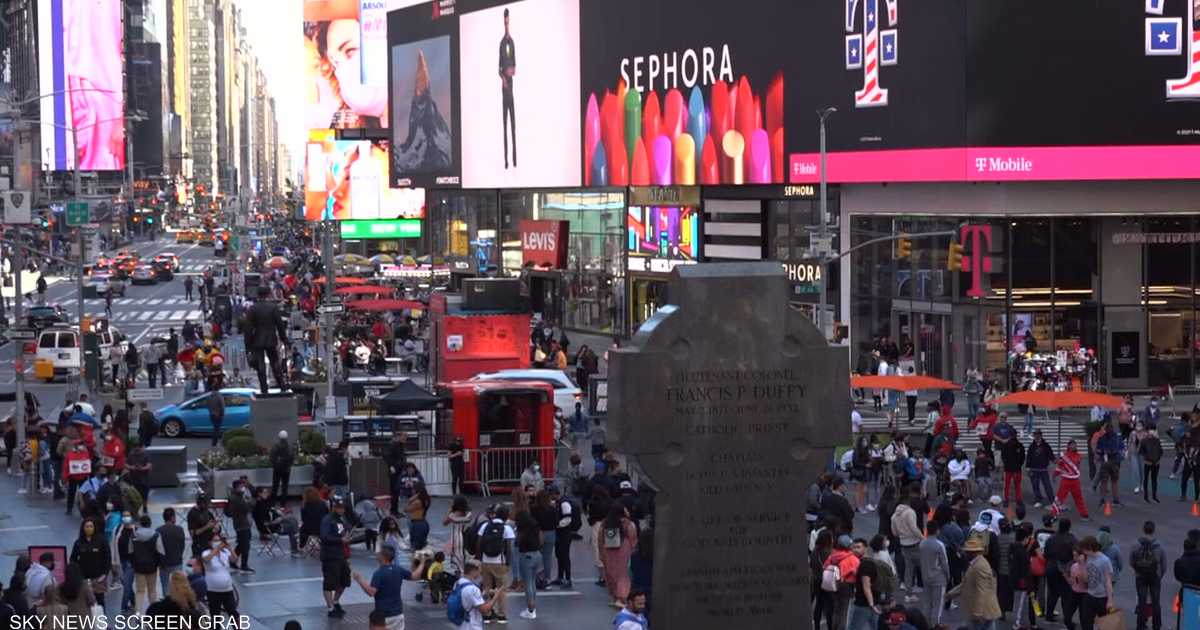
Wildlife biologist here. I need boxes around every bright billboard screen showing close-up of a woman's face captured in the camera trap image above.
[302,0,421,128]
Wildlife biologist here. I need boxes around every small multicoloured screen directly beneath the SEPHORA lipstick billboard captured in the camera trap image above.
[626,206,700,272]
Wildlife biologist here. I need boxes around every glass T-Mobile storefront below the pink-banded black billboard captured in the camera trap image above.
[850,215,1200,389]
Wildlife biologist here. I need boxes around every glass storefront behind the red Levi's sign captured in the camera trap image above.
[499,191,626,335]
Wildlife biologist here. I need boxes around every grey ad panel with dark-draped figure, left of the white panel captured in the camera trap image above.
[388,4,458,187]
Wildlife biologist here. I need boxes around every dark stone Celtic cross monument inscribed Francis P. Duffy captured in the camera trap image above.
[608,263,850,630]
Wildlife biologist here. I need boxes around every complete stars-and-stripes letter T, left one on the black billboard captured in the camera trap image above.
[846,0,900,107]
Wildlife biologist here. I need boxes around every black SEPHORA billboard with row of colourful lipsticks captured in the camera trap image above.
[580,0,800,186]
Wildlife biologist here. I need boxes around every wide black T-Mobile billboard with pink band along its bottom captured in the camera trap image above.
[788,0,1200,182]
